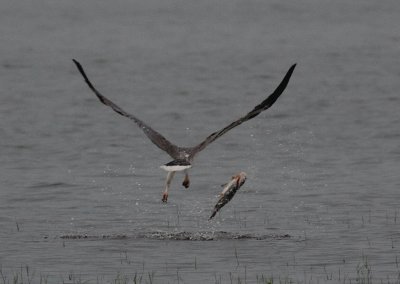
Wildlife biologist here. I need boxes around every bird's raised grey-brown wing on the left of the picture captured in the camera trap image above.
[72,59,179,159]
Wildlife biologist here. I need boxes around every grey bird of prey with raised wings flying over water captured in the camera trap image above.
[72,59,296,202]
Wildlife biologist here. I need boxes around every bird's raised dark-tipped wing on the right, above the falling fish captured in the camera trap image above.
[190,64,296,157]
